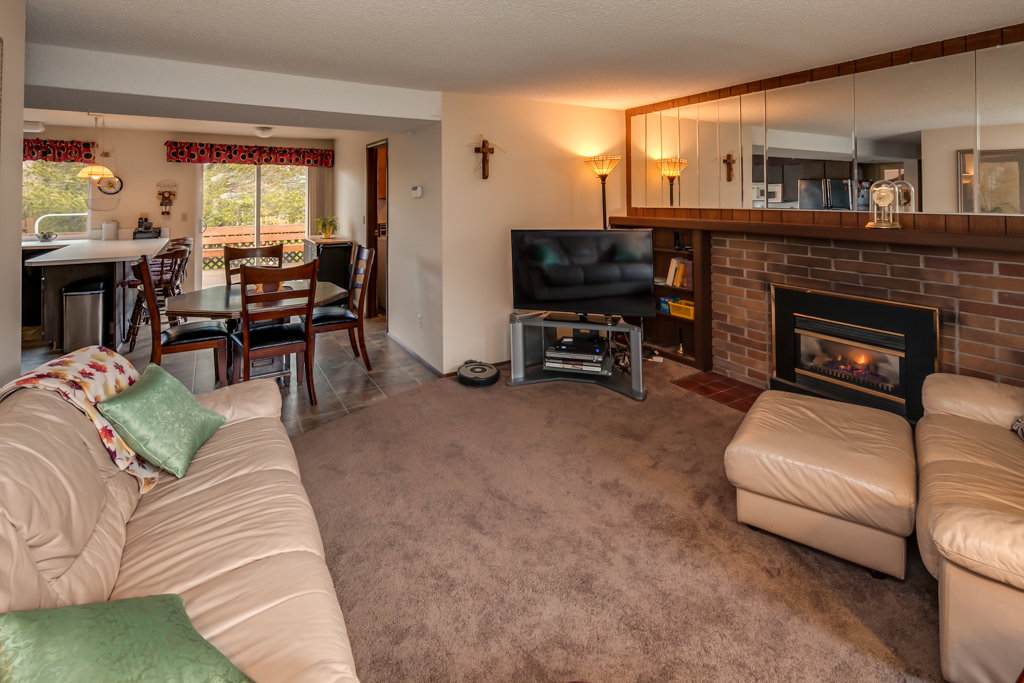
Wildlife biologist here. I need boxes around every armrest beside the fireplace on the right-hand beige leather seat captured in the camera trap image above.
[922,373,1024,429]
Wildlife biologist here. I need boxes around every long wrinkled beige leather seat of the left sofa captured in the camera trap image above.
[112,419,356,683]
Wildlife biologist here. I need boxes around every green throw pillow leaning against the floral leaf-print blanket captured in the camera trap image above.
[96,365,227,479]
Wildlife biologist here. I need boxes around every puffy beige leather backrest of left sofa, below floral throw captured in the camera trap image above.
[0,389,139,611]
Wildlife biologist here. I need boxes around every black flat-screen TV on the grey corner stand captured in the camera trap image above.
[512,230,655,317]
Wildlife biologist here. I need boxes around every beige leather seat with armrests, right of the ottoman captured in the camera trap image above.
[916,374,1024,683]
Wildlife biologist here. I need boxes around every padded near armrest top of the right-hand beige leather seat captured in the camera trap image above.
[918,460,1024,590]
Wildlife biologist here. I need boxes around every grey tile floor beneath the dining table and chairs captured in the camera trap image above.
[22,316,440,435]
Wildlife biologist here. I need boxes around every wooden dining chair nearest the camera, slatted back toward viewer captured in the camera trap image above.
[231,259,319,405]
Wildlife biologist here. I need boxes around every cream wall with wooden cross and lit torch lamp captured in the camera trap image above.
[440,92,626,372]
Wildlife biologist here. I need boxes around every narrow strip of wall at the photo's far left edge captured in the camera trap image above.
[0,0,25,384]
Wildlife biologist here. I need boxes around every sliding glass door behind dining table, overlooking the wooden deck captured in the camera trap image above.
[203,164,306,287]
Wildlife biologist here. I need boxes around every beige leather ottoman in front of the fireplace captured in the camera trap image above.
[725,391,918,579]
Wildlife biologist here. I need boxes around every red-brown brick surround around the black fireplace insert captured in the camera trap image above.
[712,232,1024,387]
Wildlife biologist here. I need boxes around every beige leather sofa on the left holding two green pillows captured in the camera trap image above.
[0,380,357,683]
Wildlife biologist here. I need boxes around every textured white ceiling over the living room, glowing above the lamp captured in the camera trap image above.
[28,0,1024,109]
